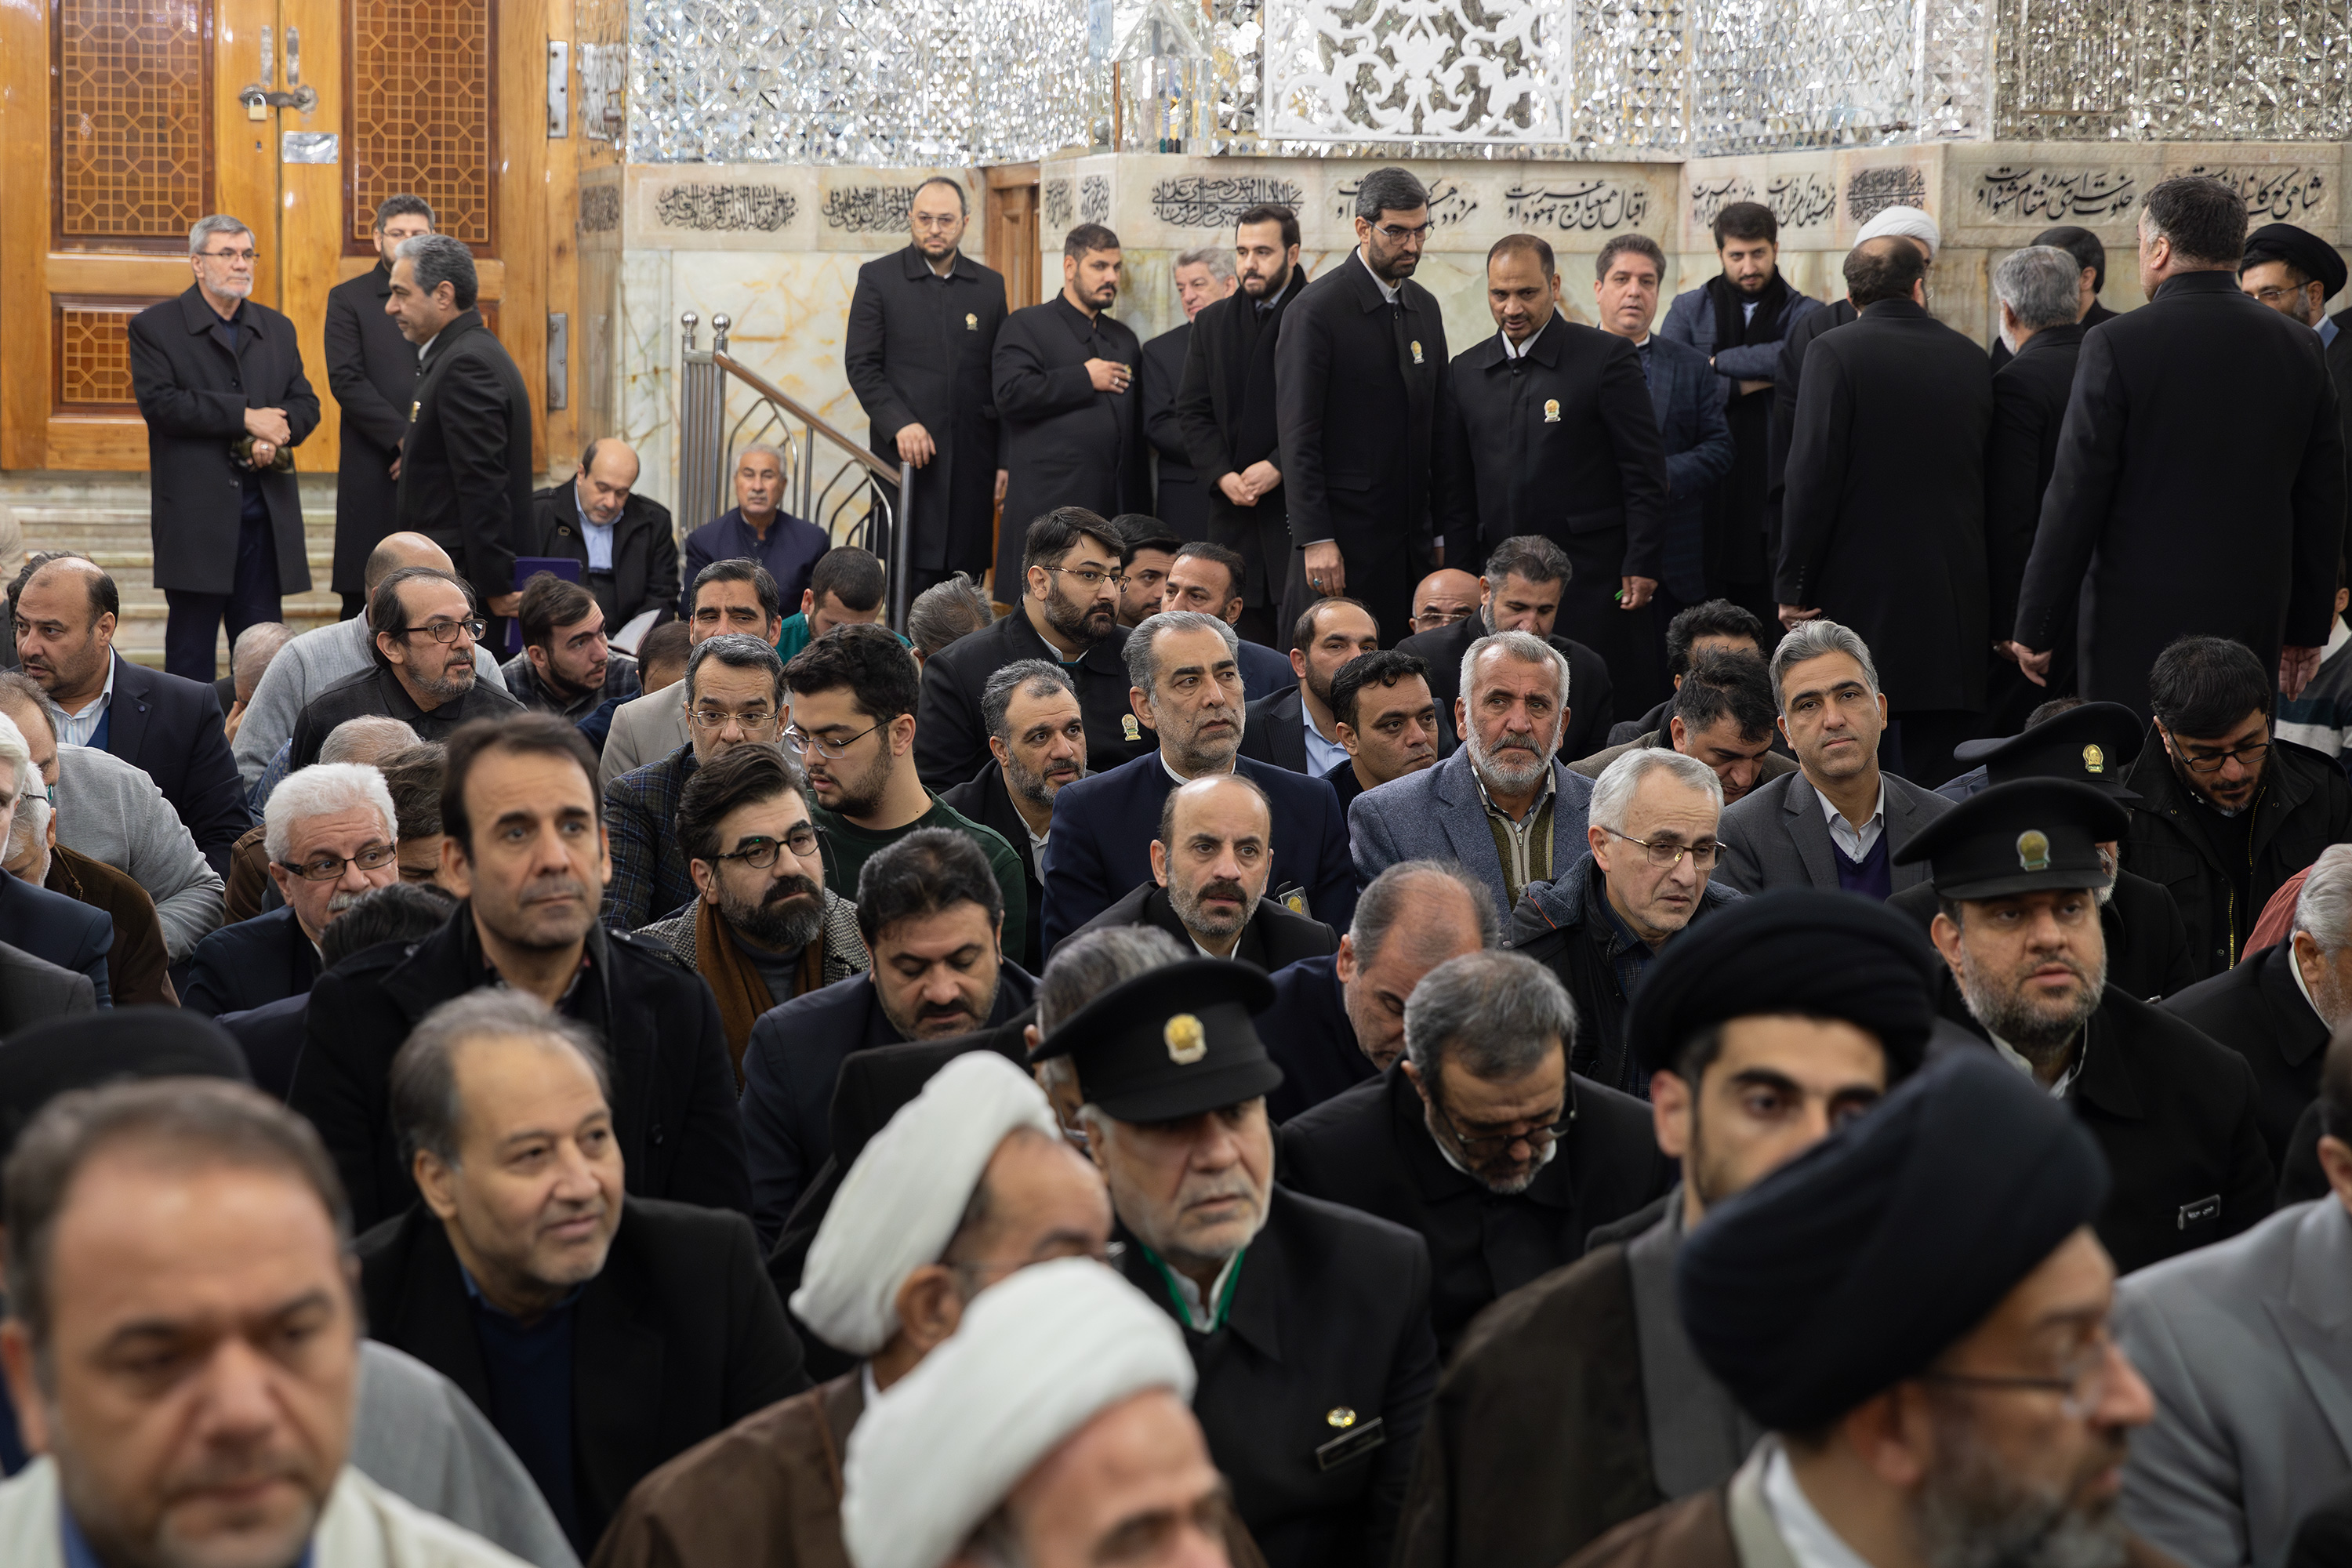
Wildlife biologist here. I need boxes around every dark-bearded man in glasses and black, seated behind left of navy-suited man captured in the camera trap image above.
[915,506,1152,789]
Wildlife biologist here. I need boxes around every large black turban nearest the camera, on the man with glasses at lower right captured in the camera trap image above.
[1684,1048,2107,1432]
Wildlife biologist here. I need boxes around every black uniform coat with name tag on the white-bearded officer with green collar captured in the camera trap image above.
[1120,1182,1437,1568]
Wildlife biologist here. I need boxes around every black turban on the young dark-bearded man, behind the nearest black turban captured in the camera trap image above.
[1625,888,1943,1083]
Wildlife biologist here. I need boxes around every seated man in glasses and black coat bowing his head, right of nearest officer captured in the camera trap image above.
[1282,952,1675,1356]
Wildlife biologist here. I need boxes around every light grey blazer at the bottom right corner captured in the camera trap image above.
[2114,1196,2352,1568]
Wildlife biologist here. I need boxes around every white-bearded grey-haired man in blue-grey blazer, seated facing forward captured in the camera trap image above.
[1348,633,1592,909]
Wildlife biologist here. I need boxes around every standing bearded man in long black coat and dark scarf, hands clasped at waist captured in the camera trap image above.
[1176,205,1308,642]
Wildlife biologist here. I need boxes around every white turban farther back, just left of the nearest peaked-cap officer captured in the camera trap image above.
[793,1051,1061,1356]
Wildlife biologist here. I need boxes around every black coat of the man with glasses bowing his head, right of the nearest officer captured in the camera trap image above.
[1282,1062,1675,1356]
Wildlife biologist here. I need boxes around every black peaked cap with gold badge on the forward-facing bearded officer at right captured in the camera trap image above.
[1896,779,2131,898]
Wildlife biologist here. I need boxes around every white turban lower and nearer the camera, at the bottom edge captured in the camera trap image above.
[842,1258,1192,1568]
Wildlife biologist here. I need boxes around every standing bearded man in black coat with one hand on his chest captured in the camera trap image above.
[988,223,1150,595]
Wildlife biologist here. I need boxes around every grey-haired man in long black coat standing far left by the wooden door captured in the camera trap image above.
[127,212,318,687]
